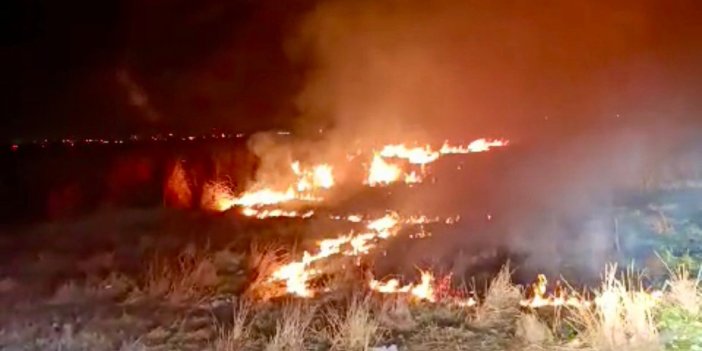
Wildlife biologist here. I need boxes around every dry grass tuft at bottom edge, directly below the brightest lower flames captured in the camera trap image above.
[265,301,316,351]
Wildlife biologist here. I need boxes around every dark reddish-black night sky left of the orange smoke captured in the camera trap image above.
[1,0,314,142]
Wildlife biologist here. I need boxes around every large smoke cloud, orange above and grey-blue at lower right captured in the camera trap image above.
[238,0,702,280]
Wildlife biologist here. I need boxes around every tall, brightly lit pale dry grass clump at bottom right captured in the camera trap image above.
[571,265,661,351]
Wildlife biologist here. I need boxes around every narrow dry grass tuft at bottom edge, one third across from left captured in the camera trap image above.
[214,299,252,351]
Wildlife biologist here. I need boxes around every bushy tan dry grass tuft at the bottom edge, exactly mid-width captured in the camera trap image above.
[324,296,381,351]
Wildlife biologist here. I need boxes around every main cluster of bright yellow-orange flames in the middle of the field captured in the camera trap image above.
[202,139,507,306]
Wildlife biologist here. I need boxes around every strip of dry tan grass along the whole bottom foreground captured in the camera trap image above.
[0,245,702,351]
